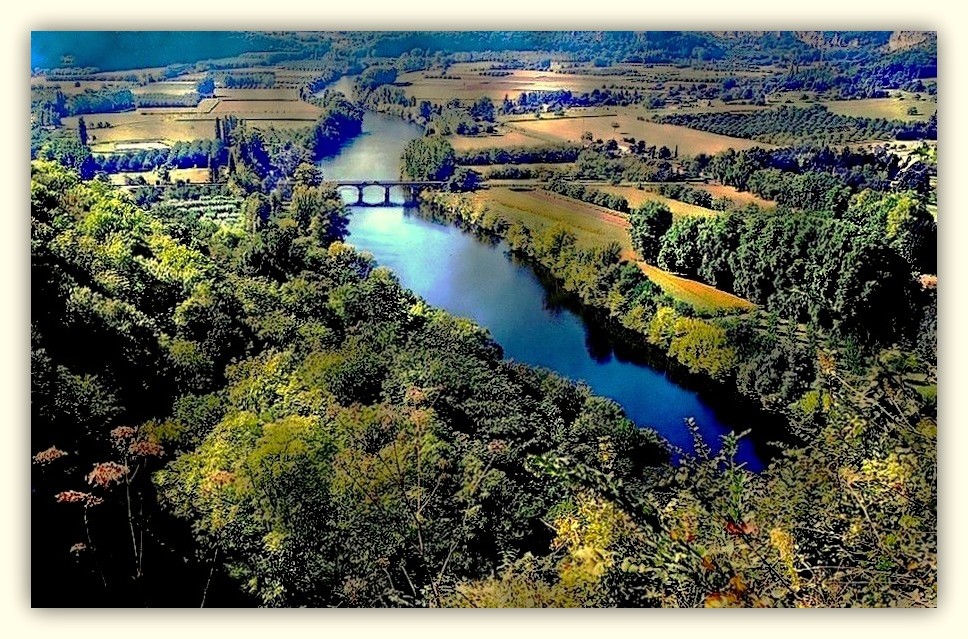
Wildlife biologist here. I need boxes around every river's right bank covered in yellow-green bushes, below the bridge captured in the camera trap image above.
[418,193,795,456]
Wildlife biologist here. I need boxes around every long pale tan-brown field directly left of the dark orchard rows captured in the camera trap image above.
[507,113,772,156]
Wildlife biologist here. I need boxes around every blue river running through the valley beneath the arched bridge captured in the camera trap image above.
[320,112,763,471]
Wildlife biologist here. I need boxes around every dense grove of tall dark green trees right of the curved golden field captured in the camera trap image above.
[631,191,937,350]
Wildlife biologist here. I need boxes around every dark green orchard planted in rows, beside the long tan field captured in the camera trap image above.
[656,104,938,145]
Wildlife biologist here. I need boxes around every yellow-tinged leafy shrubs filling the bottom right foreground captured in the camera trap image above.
[466,358,937,608]
